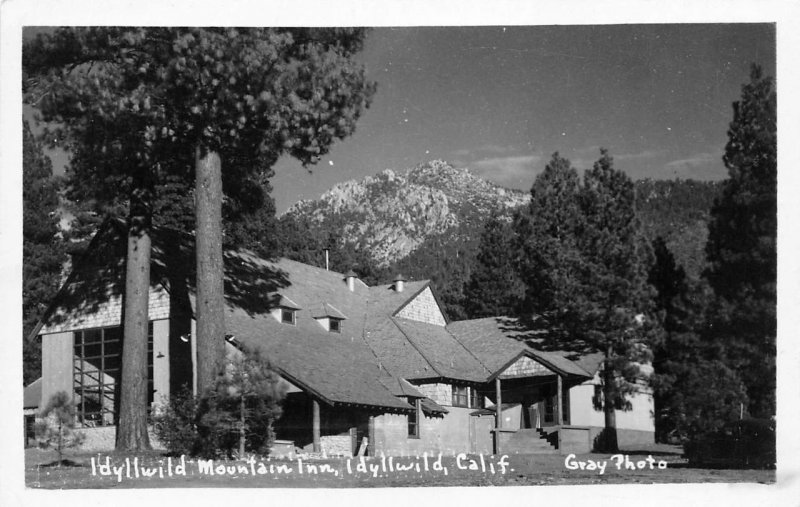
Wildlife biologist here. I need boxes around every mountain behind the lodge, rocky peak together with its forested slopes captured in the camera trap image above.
[278,161,719,319]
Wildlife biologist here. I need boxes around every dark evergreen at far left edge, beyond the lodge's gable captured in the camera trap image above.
[22,122,66,385]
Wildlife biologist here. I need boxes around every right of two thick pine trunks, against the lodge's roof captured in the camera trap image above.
[195,148,225,393]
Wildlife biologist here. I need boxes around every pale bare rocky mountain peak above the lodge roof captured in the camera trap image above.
[285,160,530,265]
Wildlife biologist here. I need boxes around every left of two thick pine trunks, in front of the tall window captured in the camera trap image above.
[116,212,151,451]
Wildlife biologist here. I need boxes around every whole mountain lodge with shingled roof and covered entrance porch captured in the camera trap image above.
[26,221,654,456]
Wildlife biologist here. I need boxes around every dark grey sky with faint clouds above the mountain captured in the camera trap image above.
[273,24,775,212]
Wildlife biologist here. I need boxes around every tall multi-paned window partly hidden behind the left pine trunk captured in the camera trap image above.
[72,322,153,426]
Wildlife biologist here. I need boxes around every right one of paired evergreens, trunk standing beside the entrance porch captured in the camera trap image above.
[577,150,656,451]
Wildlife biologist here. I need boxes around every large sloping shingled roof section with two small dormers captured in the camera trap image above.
[225,251,413,411]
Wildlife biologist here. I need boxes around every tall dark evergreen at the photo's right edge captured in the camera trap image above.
[705,66,777,417]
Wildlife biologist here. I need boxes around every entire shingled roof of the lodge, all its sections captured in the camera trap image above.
[36,221,598,413]
